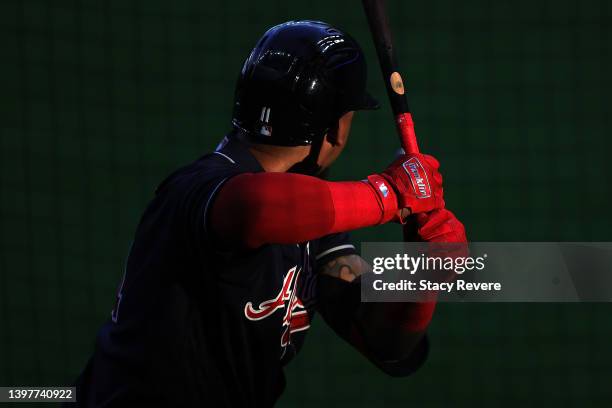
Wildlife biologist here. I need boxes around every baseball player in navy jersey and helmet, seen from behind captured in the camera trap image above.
[77,21,466,407]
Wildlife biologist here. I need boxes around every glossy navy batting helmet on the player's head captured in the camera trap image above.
[232,20,378,146]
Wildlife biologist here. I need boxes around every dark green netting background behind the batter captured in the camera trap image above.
[0,0,612,407]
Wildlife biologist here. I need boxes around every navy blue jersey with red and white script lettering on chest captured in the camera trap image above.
[77,135,355,407]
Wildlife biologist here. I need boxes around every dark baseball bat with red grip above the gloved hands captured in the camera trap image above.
[362,0,419,153]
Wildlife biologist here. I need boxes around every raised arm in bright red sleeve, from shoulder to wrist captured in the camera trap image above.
[210,173,397,248]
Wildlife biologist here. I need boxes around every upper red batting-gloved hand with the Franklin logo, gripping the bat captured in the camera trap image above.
[368,153,444,221]
